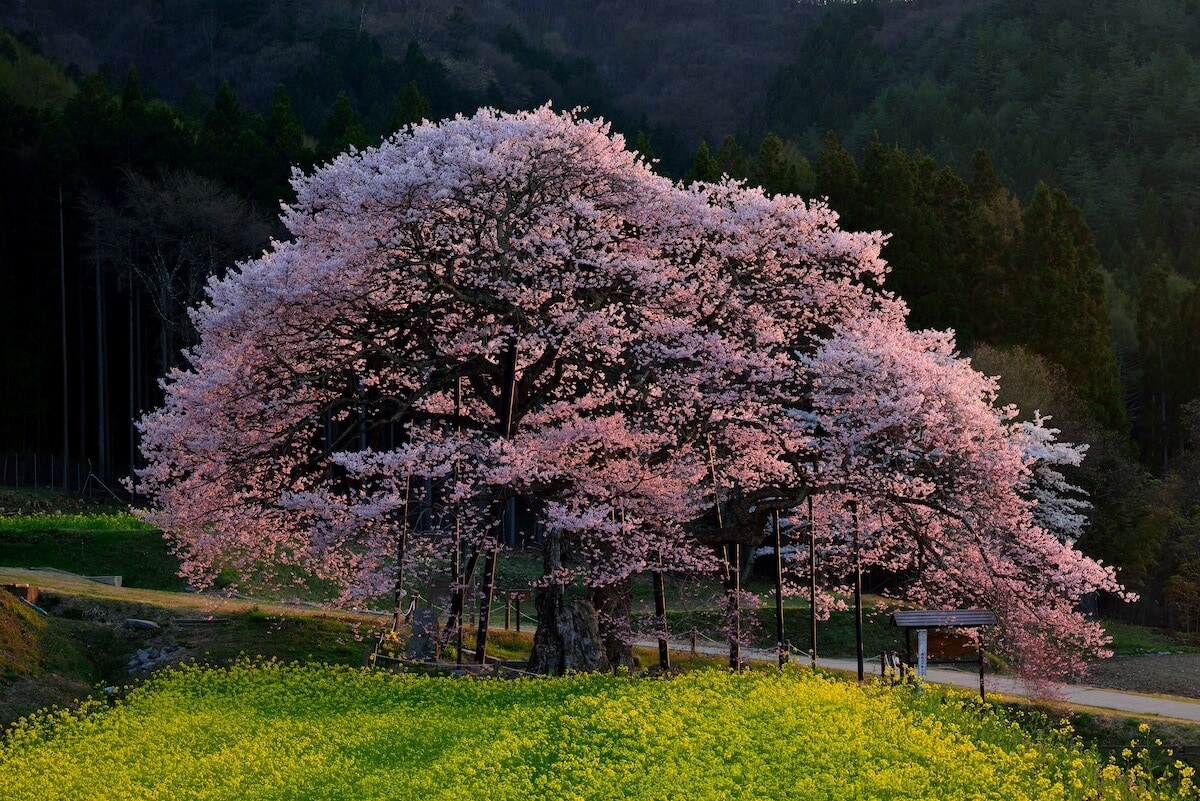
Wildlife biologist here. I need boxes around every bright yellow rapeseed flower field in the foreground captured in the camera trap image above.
[0,662,1193,801]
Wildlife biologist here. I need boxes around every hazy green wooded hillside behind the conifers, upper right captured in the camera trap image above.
[751,0,1200,468]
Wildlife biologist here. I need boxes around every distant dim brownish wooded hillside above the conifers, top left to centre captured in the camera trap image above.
[0,0,821,158]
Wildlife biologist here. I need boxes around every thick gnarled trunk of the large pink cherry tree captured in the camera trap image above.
[528,531,600,676]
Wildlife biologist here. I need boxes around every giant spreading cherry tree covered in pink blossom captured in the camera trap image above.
[139,108,1118,671]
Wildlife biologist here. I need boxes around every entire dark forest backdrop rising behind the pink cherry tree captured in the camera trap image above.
[7,0,1200,626]
